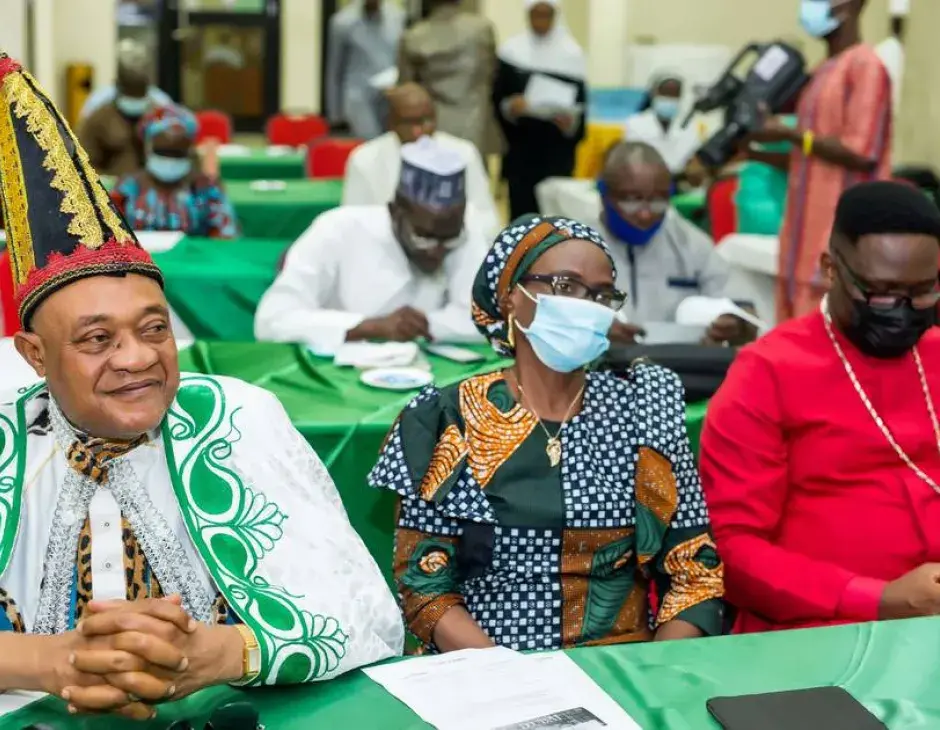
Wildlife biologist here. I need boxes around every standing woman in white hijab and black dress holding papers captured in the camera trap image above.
[493,0,587,219]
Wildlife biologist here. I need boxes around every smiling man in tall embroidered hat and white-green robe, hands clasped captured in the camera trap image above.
[0,55,403,718]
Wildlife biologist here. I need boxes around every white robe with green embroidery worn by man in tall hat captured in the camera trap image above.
[0,375,403,684]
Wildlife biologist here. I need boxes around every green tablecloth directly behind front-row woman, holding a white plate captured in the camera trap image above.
[174,342,705,581]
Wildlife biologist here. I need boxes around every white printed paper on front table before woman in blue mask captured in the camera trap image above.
[364,648,640,730]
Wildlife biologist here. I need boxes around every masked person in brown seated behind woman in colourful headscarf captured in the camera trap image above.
[78,44,168,177]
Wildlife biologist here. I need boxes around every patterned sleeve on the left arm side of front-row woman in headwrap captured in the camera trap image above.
[369,388,464,645]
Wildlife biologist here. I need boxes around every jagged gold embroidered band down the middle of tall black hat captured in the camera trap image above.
[3,73,104,248]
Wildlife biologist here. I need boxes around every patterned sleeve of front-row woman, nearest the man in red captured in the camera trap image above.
[636,368,724,636]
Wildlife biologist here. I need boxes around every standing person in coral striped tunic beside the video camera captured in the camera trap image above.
[744,0,892,322]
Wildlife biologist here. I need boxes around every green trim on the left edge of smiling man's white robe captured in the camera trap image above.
[0,383,46,576]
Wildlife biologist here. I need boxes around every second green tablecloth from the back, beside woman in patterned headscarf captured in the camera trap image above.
[225,180,343,241]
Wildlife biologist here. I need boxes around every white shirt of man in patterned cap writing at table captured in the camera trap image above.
[255,205,490,354]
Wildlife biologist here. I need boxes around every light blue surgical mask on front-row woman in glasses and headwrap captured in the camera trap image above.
[516,286,614,373]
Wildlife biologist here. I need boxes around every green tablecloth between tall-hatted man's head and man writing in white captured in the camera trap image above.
[153,238,291,342]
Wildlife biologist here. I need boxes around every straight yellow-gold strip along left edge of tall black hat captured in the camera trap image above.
[0,86,35,288]
